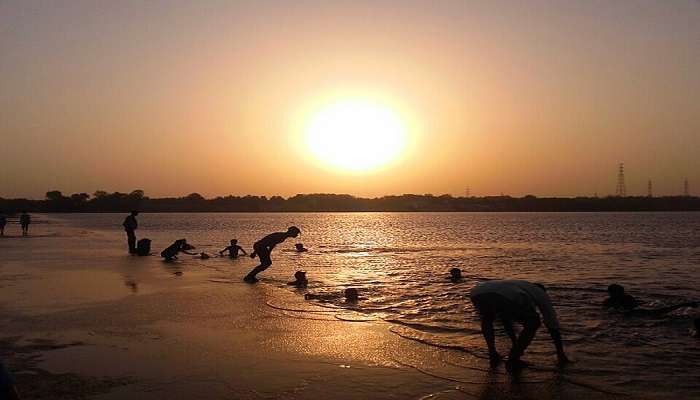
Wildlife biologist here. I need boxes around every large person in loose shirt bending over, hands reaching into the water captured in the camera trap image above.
[470,280,568,371]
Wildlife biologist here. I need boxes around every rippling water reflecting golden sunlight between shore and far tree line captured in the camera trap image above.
[35,213,700,397]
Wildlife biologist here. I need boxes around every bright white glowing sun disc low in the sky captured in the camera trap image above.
[306,100,406,172]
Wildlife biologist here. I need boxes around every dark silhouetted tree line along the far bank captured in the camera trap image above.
[0,190,700,213]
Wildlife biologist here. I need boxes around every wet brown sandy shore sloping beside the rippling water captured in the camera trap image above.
[0,217,616,399]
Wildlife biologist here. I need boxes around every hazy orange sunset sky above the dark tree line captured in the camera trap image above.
[0,0,700,198]
